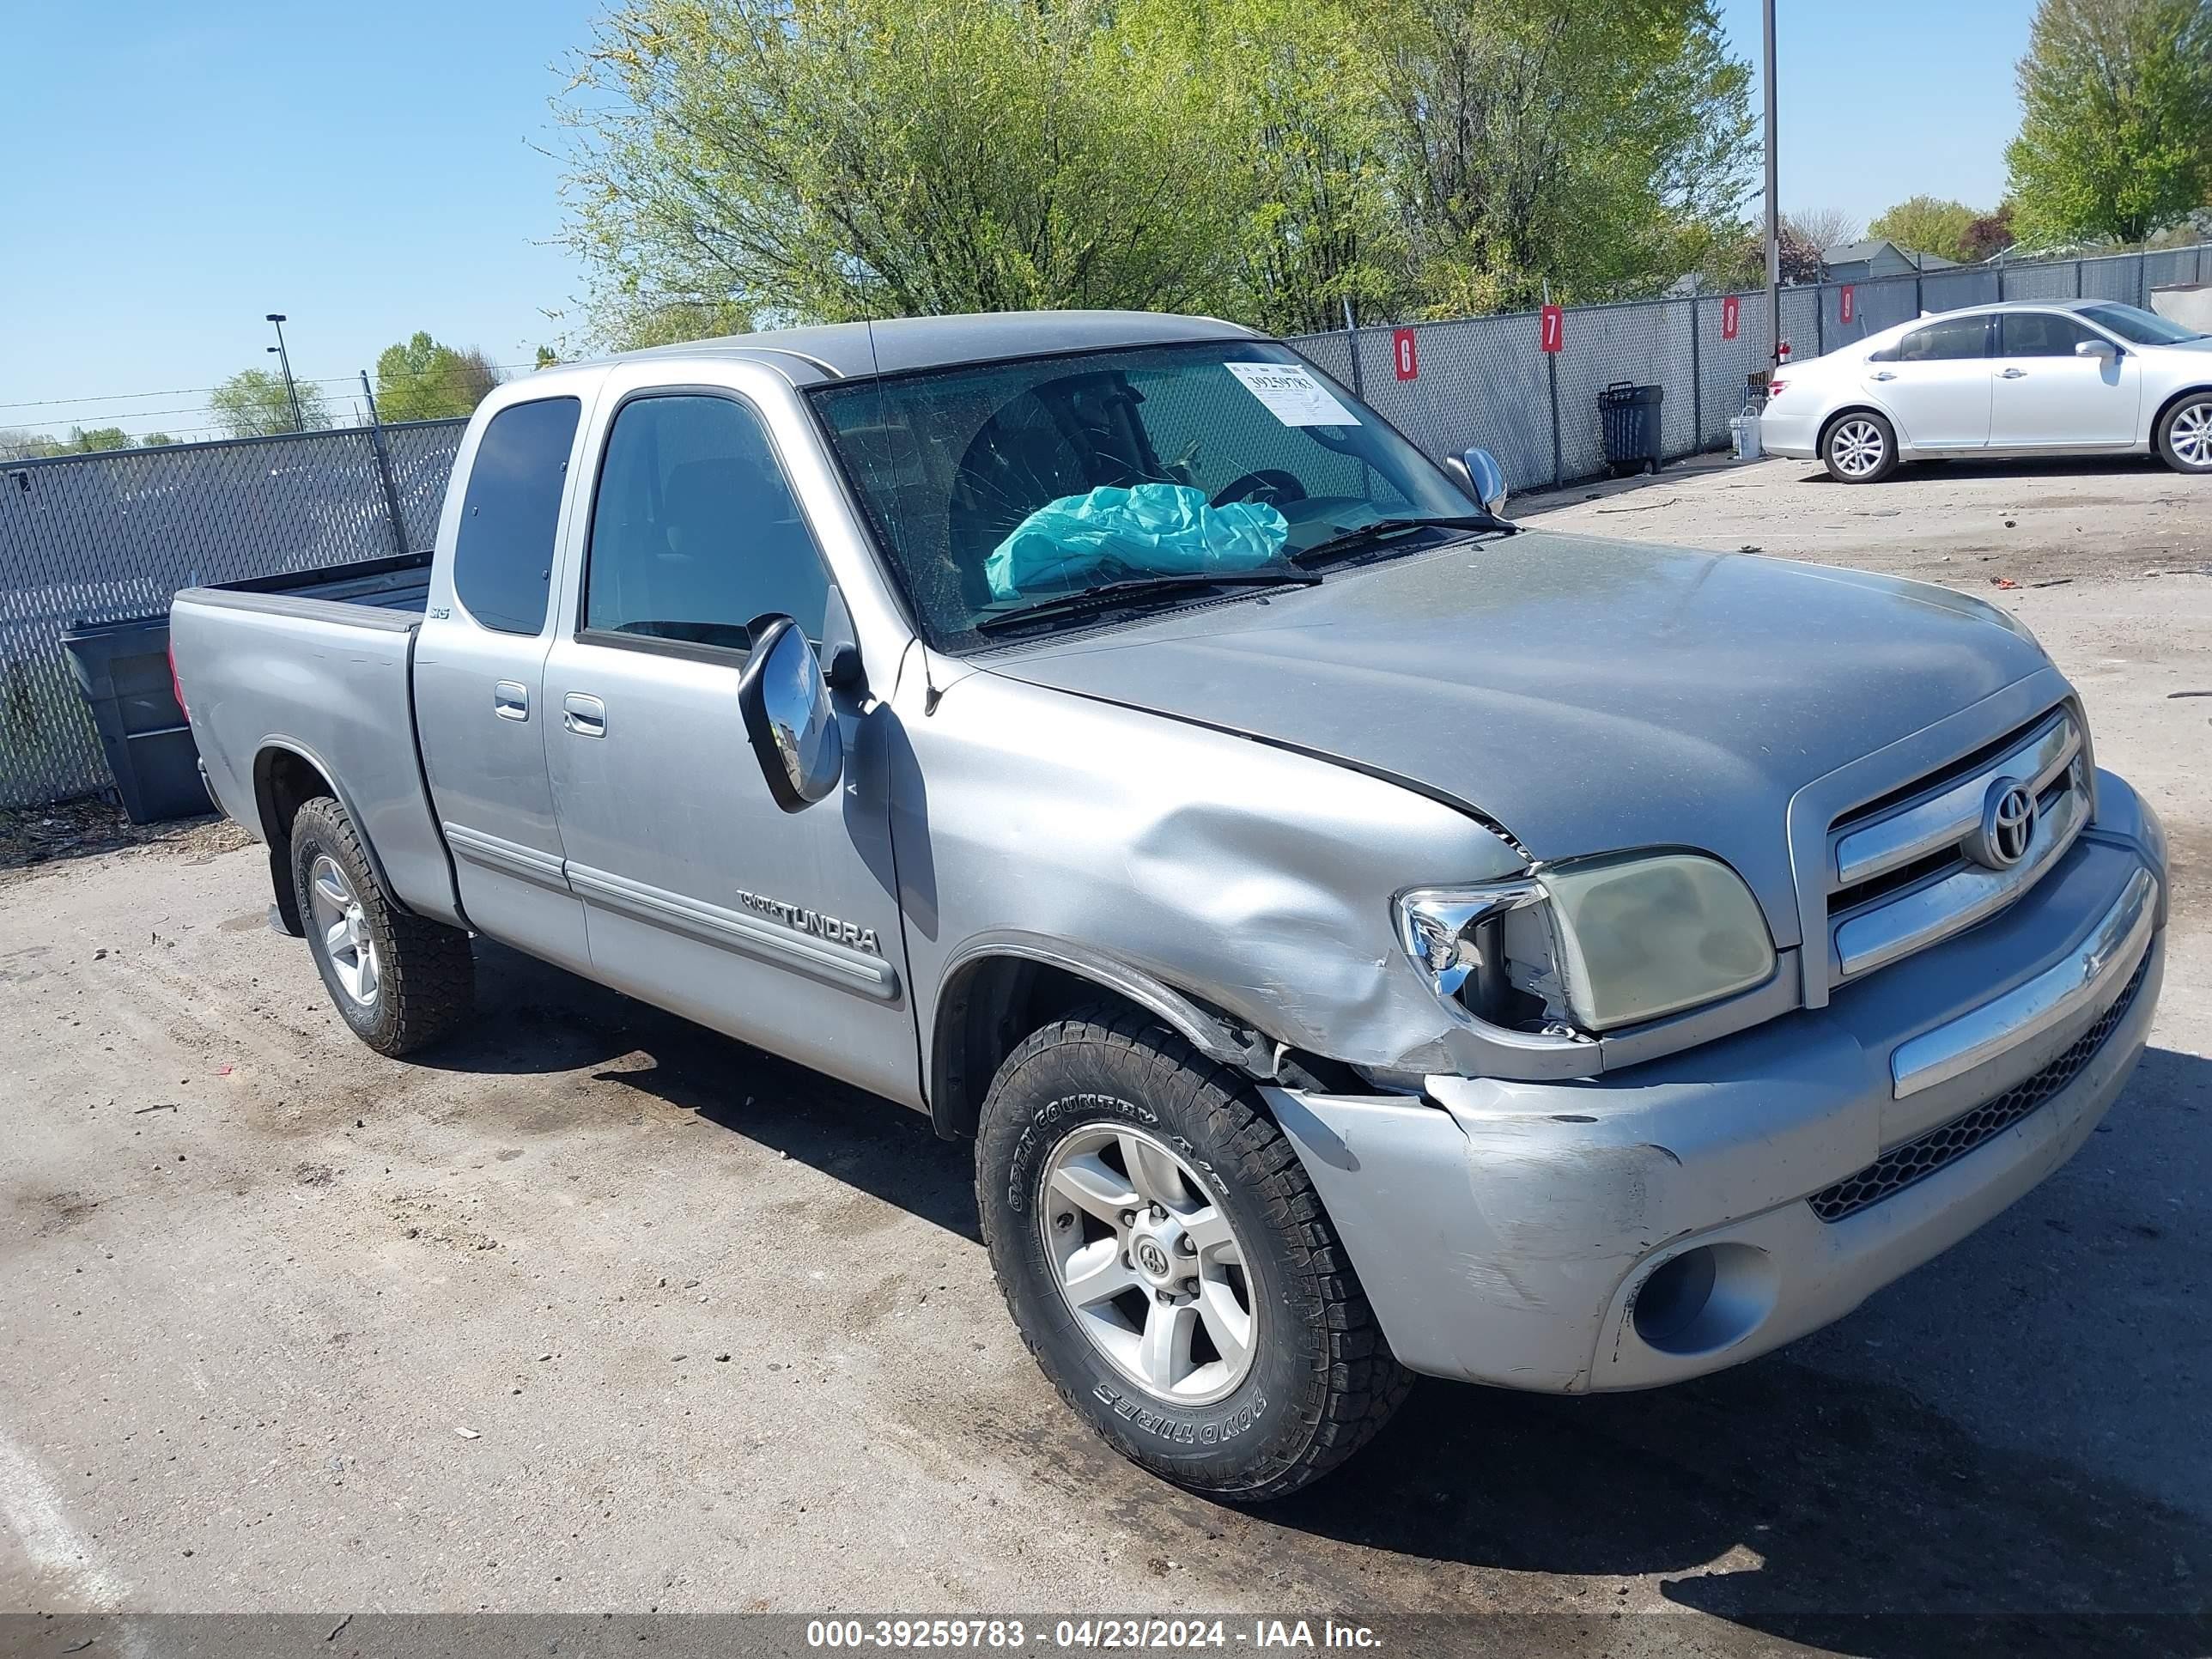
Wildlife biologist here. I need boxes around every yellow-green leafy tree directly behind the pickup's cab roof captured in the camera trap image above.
[562,0,1234,338]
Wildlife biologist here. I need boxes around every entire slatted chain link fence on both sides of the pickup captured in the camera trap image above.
[0,246,2212,805]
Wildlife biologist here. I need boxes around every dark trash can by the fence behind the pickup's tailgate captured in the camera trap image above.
[62,617,215,823]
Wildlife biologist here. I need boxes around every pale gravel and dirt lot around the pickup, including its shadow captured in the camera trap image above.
[0,448,2212,1655]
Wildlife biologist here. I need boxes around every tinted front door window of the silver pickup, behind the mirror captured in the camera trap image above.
[584,394,830,650]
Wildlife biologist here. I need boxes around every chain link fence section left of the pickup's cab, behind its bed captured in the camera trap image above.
[0,420,467,807]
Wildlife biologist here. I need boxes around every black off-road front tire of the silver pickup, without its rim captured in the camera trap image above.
[975,1006,1413,1502]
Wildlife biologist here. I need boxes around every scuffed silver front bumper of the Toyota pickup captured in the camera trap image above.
[1265,823,2166,1394]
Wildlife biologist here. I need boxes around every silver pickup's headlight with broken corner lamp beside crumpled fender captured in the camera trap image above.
[1395,852,1774,1030]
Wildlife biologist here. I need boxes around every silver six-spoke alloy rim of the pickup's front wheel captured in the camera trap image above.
[1037,1124,1259,1405]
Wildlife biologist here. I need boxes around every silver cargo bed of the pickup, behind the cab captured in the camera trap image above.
[168,553,460,922]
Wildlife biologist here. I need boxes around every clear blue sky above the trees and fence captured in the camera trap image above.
[0,0,2033,438]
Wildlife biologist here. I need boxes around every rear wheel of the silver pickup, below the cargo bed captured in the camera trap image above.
[292,794,476,1055]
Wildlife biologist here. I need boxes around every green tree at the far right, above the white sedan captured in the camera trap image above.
[2004,0,2212,248]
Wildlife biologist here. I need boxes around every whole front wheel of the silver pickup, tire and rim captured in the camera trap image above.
[975,1009,1411,1502]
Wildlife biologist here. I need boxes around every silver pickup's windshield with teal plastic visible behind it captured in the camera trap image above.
[814,341,1482,650]
